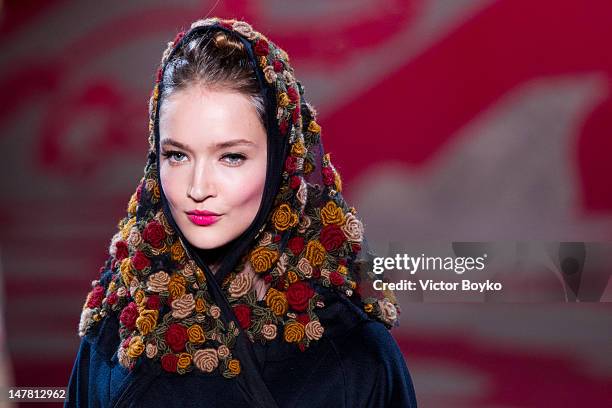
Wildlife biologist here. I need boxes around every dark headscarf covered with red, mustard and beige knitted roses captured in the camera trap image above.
[79,18,399,378]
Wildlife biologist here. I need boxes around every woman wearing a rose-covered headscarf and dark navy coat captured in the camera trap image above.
[66,18,416,407]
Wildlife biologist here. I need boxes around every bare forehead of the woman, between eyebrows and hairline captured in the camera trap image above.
[159,85,266,147]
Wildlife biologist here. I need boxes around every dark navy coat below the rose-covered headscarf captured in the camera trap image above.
[65,294,417,408]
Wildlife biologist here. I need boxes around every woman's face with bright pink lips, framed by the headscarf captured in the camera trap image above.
[159,85,267,249]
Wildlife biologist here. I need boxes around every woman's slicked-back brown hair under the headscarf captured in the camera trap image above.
[161,31,266,127]
